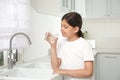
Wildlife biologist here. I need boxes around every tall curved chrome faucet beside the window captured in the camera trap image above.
[8,32,31,69]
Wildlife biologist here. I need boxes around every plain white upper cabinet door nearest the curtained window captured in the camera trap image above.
[31,0,62,15]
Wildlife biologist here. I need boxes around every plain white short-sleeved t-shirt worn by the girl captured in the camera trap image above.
[57,37,94,80]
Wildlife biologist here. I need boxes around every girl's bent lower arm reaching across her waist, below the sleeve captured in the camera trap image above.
[55,61,93,78]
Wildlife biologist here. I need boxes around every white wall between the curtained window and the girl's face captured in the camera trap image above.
[24,9,61,61]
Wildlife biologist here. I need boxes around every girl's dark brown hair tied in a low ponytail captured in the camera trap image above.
[61,12,83,37]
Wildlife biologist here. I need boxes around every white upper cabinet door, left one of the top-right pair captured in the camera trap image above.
[87,0,108,18]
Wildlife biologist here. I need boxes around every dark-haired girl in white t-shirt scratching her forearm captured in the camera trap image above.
[45,12,94,80]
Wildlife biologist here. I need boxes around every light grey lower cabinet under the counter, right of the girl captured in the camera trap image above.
[95,53,120,80]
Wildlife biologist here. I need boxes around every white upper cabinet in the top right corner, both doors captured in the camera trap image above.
[86,0,120,18]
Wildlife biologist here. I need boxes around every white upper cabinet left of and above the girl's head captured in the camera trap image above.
[31,0,75,16]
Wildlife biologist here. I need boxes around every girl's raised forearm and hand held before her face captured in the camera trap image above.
[45,32,61,71]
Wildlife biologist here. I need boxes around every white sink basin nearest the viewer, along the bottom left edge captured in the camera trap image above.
[0,68,60,80]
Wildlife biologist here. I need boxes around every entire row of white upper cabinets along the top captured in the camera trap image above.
[31,0,120,18]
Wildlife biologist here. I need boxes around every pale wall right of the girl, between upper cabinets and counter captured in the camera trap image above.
[83,19,120,49]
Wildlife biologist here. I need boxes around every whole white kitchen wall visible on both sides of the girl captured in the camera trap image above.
[24,9,120,61]
